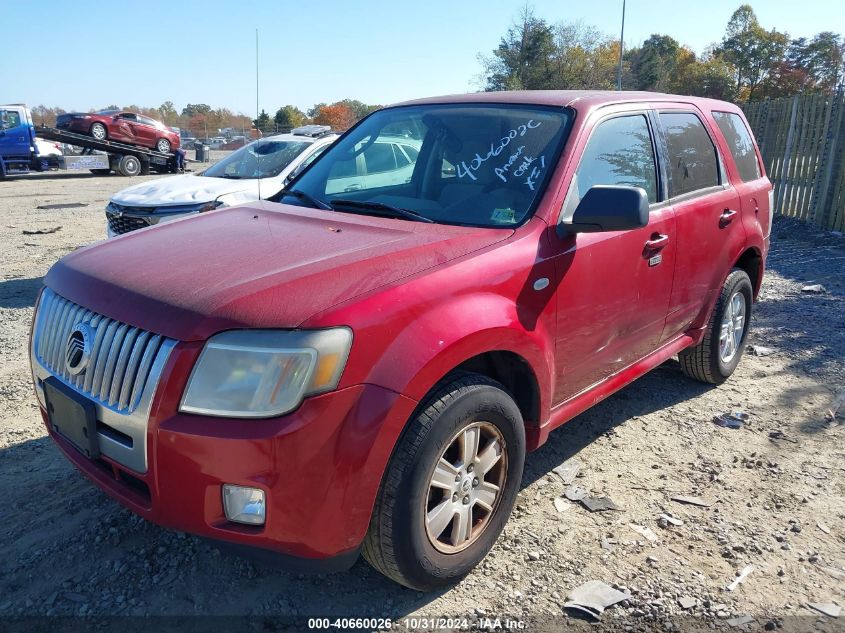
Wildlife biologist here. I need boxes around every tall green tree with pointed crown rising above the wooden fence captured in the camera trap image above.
[715,4,789,100]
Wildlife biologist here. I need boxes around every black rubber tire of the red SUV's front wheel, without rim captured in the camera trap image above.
[363,374,525,591]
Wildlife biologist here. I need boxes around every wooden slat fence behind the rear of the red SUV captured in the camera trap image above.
[743,90,845,231]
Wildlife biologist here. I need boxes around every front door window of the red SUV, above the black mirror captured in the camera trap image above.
[570,114,657,206]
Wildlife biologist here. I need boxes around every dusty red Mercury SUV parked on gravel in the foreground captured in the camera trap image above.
[31,92,771,589]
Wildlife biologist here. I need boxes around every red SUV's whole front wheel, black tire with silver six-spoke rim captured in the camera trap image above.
[363,374,525,591]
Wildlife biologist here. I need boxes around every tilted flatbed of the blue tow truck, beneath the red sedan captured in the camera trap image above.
[35,127,176,176]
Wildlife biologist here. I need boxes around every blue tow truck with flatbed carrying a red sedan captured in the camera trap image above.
[0,103,176,179]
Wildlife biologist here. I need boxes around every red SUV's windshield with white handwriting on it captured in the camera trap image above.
[274,104,570,227]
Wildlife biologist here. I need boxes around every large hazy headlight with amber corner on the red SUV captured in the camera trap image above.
[179,327,352,418]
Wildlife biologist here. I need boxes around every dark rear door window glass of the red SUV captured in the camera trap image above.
[659,112,719,198]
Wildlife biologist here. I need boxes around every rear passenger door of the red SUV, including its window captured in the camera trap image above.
[657,106,745,341]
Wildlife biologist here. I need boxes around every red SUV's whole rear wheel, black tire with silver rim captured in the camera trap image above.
[678,268,754,385]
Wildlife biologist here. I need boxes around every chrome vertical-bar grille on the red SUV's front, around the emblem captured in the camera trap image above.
[33,288,175,415]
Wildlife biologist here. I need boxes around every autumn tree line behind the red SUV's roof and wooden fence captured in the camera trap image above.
[479,4,845,102]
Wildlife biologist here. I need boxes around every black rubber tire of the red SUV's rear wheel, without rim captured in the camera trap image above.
[678,268,754,385]
